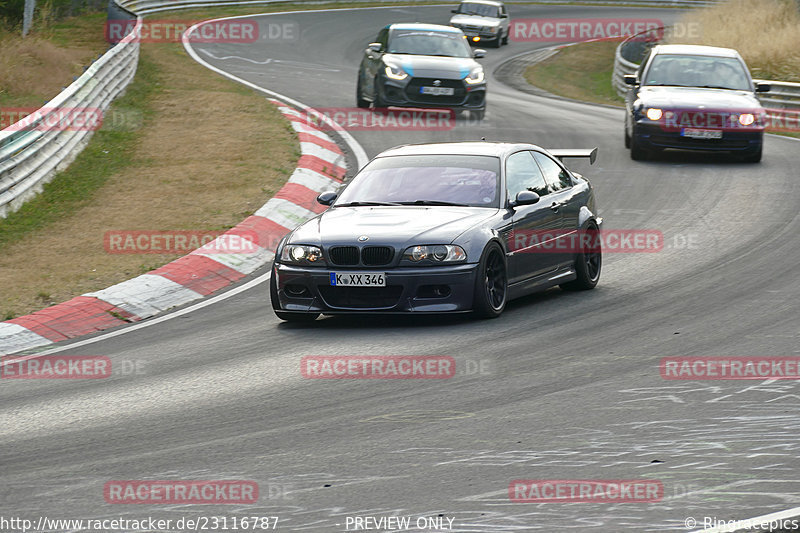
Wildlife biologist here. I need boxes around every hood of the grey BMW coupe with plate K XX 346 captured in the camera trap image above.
[289,206,498,248]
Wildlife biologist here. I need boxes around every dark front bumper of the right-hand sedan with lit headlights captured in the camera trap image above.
[633,120,764,152]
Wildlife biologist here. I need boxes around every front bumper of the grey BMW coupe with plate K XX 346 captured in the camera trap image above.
[272,263,478,314]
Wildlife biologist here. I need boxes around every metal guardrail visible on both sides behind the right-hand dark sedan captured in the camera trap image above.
[611,28,800,120]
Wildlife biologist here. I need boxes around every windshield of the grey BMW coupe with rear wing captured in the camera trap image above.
[334,155,500,207]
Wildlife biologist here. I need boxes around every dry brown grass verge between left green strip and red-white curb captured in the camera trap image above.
[0,44,299,319]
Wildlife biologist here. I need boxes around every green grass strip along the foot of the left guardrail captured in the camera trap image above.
[0,51,160,250]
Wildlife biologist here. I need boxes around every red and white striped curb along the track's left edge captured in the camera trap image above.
[0,99,347,354]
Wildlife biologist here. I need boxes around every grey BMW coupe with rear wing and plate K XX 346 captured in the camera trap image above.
[270,142,602,321]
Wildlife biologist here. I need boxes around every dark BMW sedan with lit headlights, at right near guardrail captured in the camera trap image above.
[625,45,770,162]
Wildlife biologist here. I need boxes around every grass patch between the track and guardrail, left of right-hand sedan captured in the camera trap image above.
[525,41,624,106]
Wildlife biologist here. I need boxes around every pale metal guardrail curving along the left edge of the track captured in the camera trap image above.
[0,6,141,218]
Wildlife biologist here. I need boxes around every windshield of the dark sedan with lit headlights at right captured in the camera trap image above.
[642,54,752,91]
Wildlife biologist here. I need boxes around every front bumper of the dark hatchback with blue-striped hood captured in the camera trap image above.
[378,76,486,110]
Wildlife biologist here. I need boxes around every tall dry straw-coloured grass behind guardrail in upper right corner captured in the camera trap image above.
[676,0,800,81]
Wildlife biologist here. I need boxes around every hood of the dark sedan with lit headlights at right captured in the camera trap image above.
[638,86,761,110]
